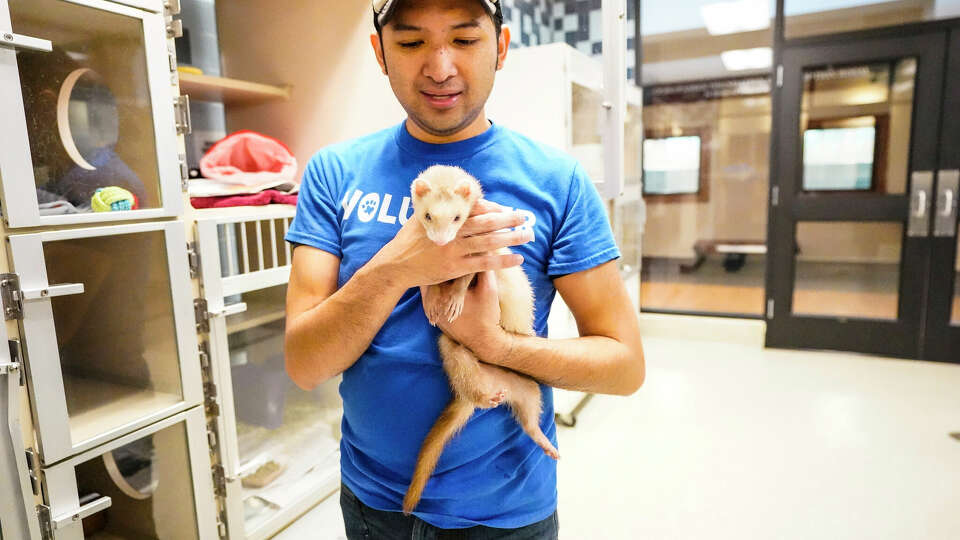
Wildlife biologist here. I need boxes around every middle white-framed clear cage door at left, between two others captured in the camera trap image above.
[9,222,202,464]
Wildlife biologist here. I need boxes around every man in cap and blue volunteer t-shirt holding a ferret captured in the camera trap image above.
[286,0,644,539]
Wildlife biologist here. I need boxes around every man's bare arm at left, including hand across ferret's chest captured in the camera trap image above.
[284,201,532,390]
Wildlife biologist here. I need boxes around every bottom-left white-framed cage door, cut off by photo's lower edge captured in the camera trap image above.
[41,407,220,540]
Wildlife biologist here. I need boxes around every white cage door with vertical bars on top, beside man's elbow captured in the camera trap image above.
[197,206,342,539]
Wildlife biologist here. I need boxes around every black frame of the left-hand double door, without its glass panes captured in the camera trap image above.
[766,26,947,358]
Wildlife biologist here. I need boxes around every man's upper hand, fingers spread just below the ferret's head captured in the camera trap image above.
[371,200,533,288]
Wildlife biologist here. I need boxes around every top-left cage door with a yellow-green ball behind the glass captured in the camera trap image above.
[0,0,183,227]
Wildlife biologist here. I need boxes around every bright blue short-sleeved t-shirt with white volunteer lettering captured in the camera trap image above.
[286,119,620,528]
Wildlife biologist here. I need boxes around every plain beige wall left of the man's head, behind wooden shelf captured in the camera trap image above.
[217,0,406,181]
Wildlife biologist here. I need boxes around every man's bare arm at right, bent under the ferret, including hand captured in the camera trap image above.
[440,261,646,395]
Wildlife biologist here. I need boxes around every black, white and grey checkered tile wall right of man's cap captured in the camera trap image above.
[503,0,637,81]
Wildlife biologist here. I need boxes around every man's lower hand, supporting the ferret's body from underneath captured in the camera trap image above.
[420,271,510,361]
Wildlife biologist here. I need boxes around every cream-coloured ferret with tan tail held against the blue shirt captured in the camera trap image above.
[403,165,560,515]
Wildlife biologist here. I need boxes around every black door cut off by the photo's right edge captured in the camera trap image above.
[924,27,960,362]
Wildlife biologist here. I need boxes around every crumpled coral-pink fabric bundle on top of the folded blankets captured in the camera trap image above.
[200,130,297,186]
